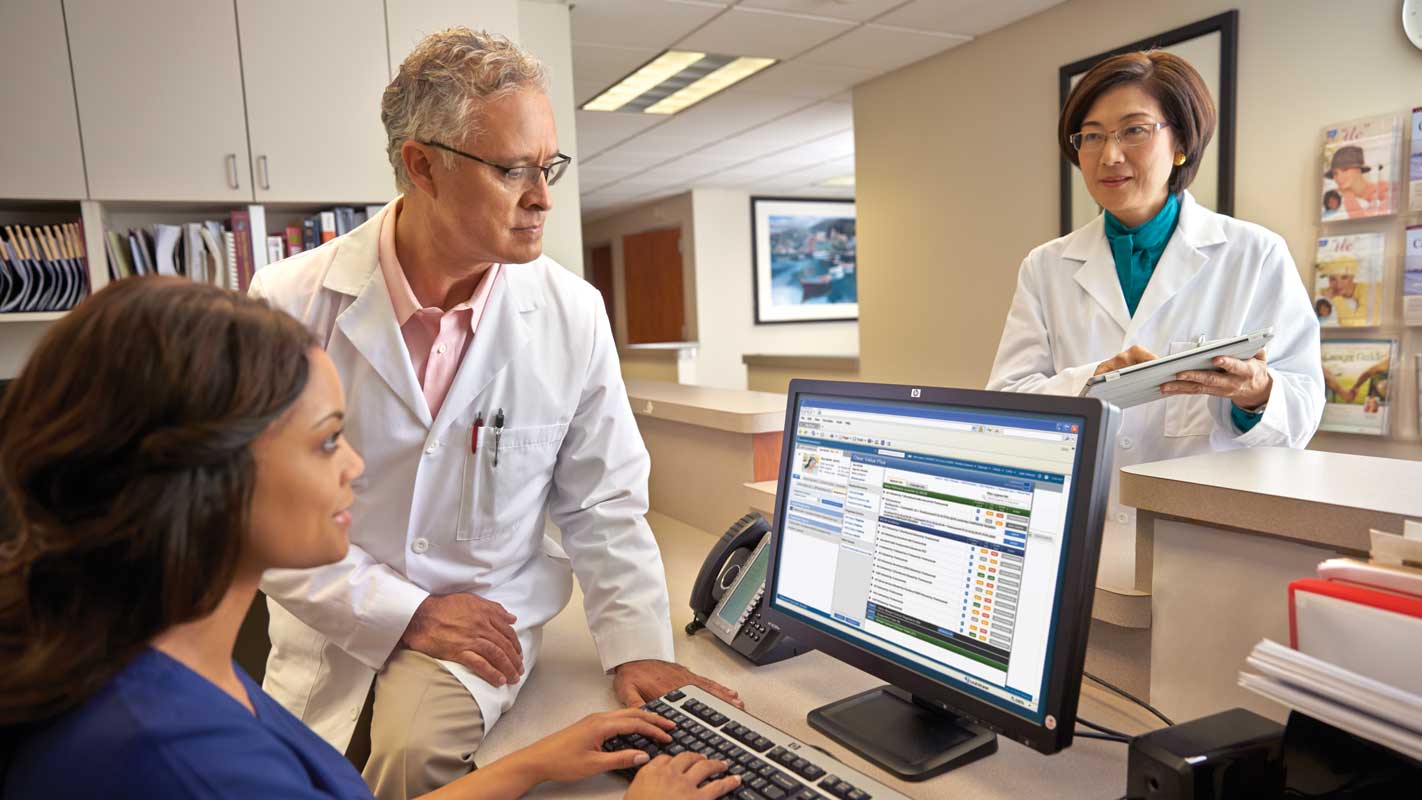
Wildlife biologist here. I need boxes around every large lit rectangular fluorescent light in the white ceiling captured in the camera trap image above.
[582,50,776,115]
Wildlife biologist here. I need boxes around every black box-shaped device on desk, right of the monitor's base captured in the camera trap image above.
[1126,708,1284,800]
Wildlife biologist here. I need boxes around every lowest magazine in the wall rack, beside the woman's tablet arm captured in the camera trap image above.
[1318,338,1398,436]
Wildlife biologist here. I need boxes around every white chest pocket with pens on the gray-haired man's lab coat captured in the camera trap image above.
[455,422,567,541]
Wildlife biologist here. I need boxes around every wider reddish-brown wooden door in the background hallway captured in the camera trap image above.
[623,227,687,344]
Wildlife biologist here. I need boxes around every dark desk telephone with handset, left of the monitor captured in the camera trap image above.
[687,513,809,664]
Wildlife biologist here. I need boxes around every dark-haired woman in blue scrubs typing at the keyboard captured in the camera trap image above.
[0,279,739,800]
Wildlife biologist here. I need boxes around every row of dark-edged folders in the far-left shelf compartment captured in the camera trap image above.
[0,222,90,314]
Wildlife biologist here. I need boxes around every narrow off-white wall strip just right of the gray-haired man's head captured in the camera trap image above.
[518,0,583,274]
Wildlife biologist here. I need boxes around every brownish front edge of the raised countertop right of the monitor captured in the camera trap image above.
[1121,470,1405,553]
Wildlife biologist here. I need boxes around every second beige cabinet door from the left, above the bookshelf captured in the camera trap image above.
[64,0,253,202]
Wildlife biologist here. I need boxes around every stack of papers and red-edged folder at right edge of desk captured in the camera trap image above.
[1240,521,1422,760]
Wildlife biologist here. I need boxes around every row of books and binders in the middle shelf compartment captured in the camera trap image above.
[105,210,255,291]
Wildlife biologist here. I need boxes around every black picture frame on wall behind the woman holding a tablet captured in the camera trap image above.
[1058,9,1240,236]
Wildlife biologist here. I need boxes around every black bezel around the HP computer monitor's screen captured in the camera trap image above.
[765,379,1119,753]
